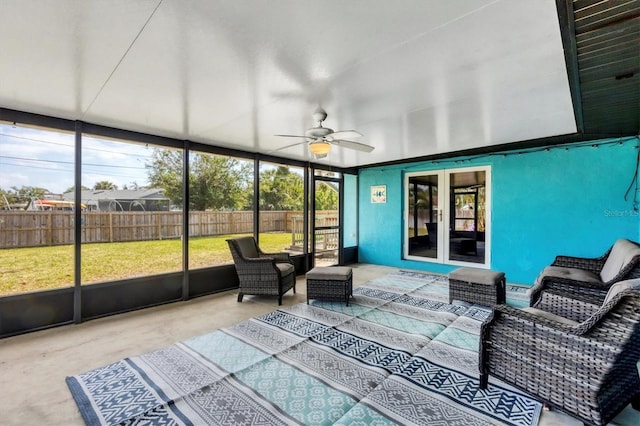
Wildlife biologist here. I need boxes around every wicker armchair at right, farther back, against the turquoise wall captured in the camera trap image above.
[529,239,640,312]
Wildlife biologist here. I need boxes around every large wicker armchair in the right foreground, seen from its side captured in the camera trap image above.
[480,279,640,425]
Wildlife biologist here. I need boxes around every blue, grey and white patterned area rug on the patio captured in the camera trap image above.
[67,271,541,425]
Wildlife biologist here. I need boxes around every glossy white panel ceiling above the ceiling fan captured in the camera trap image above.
[0,0,576,167]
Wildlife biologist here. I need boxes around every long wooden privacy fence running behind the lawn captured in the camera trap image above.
[0,211,337,248]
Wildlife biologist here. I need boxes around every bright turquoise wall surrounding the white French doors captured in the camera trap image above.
[359,138,640,284]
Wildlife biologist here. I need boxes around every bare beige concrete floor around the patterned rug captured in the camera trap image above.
[0,264,640,426]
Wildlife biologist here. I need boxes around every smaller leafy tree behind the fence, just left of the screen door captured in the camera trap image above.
[260,166,304,210]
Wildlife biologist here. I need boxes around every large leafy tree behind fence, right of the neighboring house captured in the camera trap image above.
[146,149,253,211]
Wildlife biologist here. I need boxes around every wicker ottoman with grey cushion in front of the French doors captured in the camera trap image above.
[449,268,506,306]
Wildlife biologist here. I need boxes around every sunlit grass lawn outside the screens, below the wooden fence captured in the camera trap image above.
[0,233,291,295]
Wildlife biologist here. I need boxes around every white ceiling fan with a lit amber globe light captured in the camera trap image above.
[276,107,373,159]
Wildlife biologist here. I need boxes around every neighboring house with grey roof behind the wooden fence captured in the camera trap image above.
[63,188,171,212]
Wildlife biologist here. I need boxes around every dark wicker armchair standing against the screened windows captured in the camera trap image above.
[227,237,296,305]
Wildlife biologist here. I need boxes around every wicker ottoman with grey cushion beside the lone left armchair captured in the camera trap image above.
[307,266,353,306]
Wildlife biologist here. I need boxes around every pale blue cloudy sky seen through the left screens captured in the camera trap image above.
[0,123,153,194]
